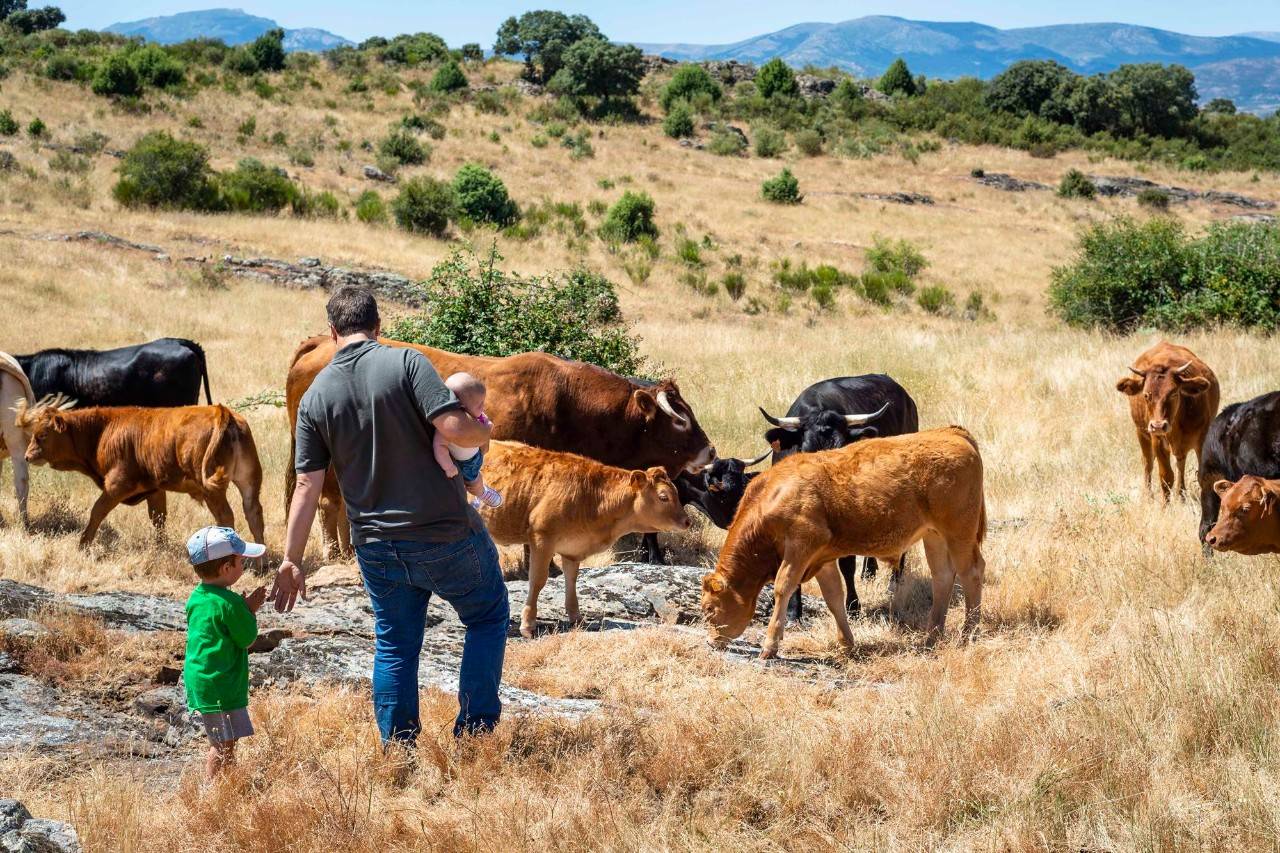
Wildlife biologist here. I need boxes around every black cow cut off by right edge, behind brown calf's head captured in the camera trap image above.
[1199,391,1280,545]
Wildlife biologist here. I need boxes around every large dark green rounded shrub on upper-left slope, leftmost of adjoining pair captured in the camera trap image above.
[111,131,216,210]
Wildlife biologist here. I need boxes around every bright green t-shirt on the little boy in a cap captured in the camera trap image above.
[182,584,257,713]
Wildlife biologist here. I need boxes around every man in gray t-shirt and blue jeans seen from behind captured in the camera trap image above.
[271,287,508,744]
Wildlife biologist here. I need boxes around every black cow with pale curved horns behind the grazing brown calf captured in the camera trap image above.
[760,373,920,619]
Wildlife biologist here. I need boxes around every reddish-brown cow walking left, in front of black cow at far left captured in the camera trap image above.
[18,402,265,548]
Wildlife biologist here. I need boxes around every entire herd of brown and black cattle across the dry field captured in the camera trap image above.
[0,336,1280,657]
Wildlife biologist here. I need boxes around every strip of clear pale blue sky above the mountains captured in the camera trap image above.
[57,0,1280,46]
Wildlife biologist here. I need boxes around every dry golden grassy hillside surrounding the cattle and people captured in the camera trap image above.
[0,48,1280,853]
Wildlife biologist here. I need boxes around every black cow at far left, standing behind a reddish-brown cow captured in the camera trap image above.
[14,338,214,407]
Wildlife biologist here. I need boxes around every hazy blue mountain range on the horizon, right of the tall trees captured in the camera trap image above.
[637,15,1280,113]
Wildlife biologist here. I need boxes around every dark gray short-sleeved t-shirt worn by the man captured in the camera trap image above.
[293,341,477,544]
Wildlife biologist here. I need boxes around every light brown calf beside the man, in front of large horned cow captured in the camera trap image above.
[481,442,690,637]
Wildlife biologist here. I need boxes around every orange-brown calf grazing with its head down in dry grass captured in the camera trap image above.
[703,427,987,658]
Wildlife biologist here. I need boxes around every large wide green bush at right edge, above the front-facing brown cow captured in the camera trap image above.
[1050,216,1280,330]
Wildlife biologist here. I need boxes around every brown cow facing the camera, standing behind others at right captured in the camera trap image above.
[1116,341,1219,501]
